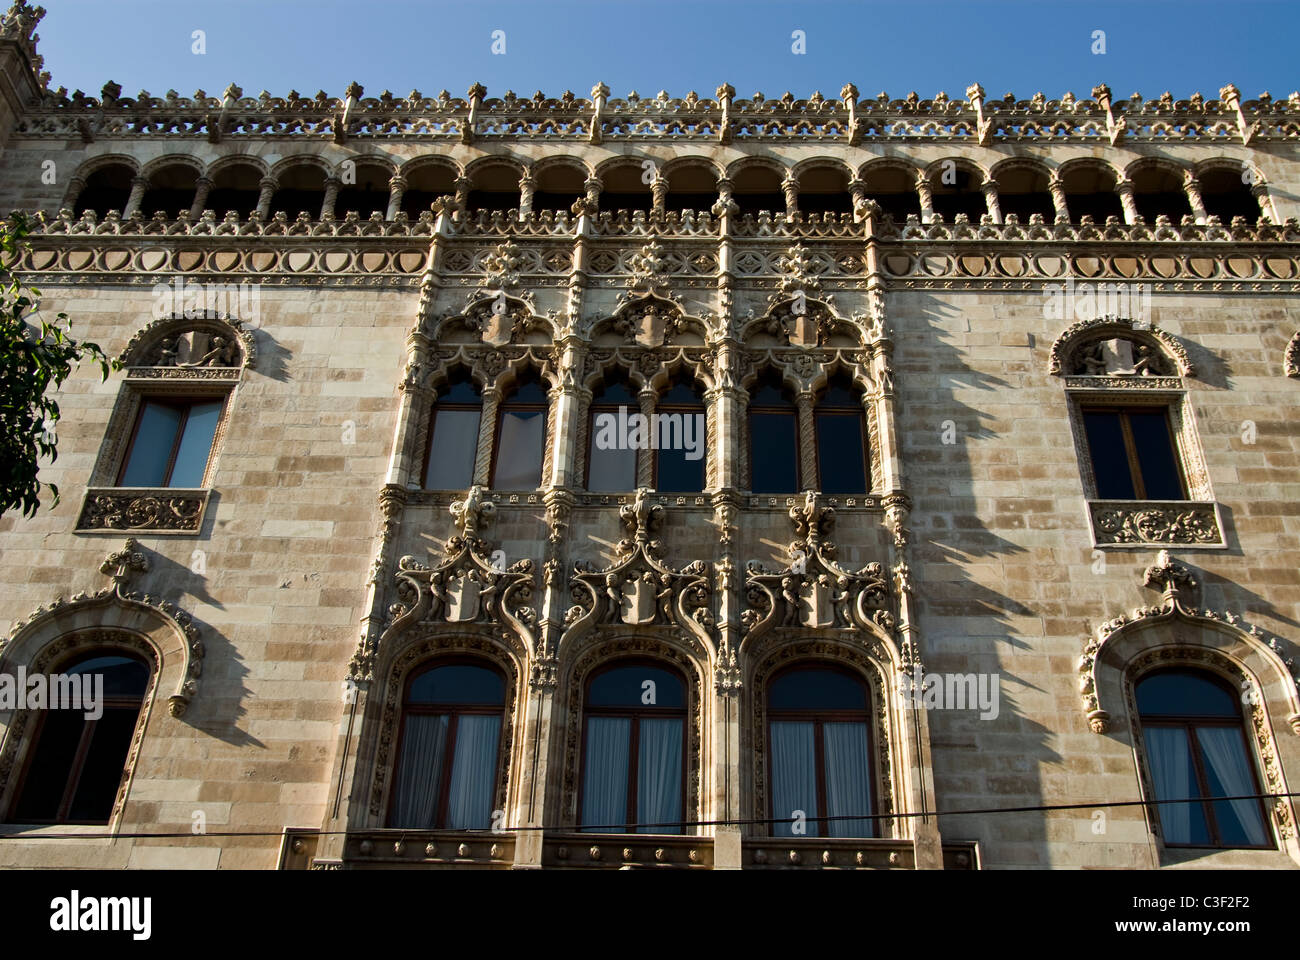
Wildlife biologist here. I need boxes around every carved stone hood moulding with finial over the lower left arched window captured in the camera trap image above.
[0,540,204,717]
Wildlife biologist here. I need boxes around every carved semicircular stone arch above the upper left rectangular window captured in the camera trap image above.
[118,313,257,379]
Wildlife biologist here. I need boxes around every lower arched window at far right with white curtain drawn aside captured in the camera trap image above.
[1138,670,1273,848]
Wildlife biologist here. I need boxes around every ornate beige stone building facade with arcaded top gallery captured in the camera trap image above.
[0,3,1300,869]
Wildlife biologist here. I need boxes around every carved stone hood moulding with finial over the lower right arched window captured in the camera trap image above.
[1079,550,1300,735]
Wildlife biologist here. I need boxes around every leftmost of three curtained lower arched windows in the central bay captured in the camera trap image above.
[389,662,506,830]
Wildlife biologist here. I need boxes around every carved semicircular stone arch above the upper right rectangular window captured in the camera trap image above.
[1048,310,1196,385]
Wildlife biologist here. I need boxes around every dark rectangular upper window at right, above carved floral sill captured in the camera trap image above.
[1083,407,1187,500]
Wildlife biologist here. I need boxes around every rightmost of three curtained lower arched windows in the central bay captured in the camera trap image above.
[767,666,875,836]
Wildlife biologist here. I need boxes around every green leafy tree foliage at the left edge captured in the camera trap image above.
[0,213,121,516]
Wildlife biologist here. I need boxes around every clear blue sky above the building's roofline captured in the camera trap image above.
[25,0,1300,99]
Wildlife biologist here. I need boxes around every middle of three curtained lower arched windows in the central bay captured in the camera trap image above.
[579,661,686,834]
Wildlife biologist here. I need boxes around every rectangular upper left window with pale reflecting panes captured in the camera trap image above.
[118,399,225,488]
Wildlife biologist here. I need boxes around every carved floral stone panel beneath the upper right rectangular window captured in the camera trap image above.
[1087,500,1227,550]
